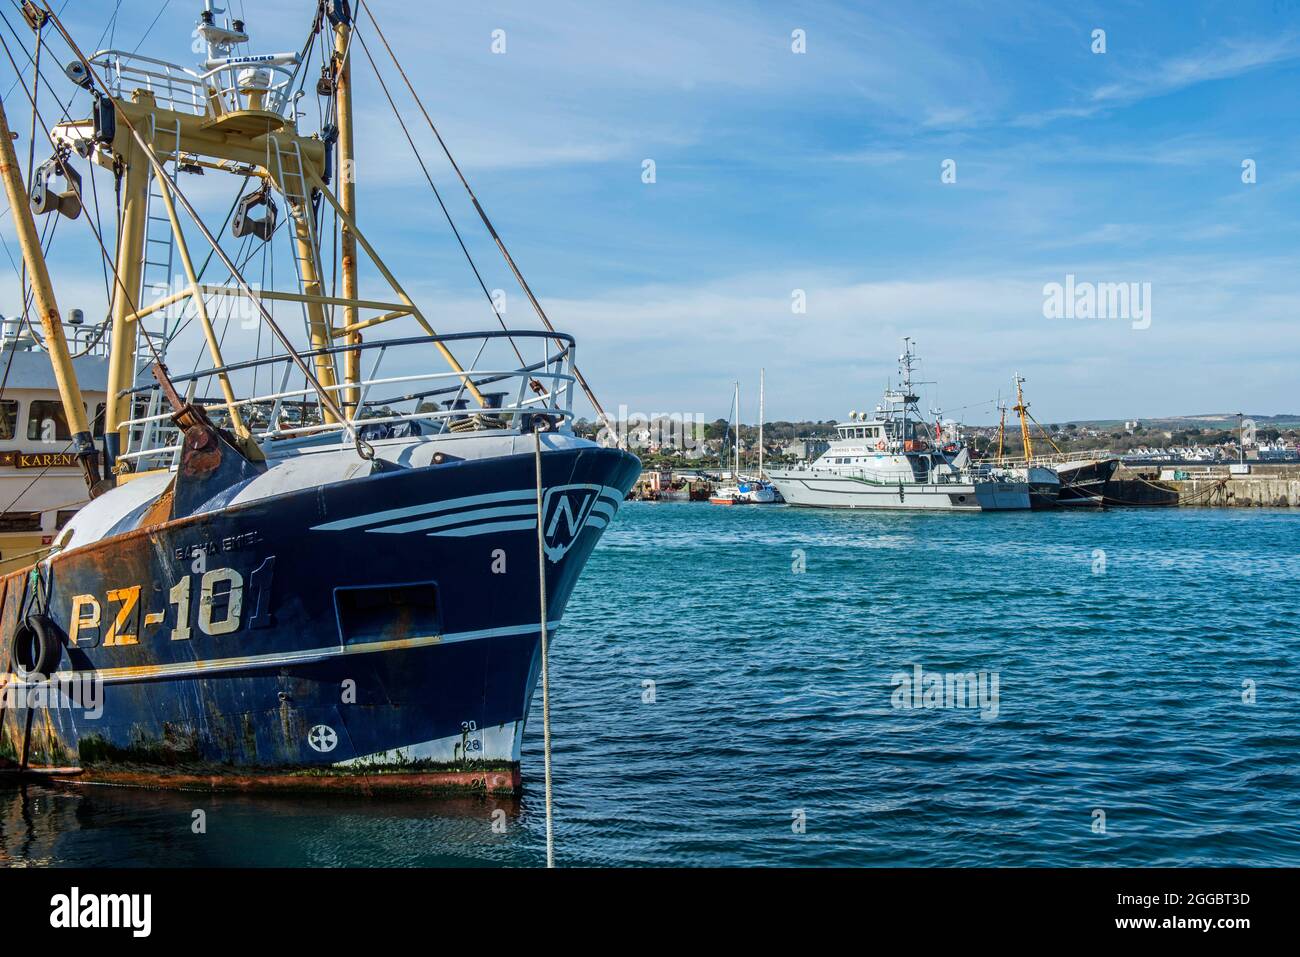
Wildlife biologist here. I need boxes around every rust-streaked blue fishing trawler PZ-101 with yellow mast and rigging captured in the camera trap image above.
[0,0,640,792]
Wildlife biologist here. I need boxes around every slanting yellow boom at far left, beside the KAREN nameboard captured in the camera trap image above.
[0,95,108,495]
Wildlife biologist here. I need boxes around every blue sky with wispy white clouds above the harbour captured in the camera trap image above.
[0,0,1300,423]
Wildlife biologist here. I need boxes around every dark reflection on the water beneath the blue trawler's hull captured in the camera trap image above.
[0,785,541,867]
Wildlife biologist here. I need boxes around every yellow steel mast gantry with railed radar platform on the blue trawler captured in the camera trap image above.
[24,0,501,473]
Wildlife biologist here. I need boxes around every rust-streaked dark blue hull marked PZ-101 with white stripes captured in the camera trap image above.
[3,449,640,785]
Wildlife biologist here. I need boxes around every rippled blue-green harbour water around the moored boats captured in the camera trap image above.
[0,503,1300,866]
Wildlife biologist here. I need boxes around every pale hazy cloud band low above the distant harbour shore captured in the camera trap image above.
[392,256,1300,419]
